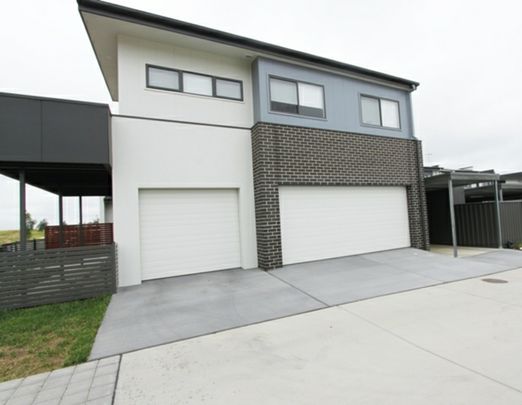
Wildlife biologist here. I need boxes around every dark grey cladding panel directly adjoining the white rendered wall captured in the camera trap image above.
[42,101,109,163]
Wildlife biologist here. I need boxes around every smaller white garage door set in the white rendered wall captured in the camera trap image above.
[139,189,240,280]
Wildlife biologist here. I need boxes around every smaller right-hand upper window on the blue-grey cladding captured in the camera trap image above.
[361,96,401,129]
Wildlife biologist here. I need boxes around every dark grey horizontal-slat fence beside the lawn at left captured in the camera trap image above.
[0,244,117,309]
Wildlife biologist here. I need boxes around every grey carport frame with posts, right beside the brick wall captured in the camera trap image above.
[424,170,503,257]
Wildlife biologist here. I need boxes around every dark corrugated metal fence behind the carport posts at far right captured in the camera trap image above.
[455,201,522,247]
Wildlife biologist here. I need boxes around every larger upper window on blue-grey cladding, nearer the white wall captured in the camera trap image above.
[270,77,325,118]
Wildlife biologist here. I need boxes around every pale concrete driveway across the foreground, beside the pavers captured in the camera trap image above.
[115,269,522,405]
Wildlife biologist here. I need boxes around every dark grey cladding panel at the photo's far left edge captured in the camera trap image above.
[0,96,41,162]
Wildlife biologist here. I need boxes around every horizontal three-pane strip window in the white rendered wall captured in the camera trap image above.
[147,65,243,101]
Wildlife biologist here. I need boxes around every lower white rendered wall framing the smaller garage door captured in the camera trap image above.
[112,117,257,286]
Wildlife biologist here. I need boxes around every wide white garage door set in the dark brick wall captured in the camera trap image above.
[279,186,410,264]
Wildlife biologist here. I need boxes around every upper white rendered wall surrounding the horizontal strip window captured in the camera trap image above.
[118,36,253,128]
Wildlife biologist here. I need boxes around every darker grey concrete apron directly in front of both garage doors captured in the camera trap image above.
[90,249,522,359]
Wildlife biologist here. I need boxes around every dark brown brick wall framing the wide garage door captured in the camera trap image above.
[252,123,429,269]
